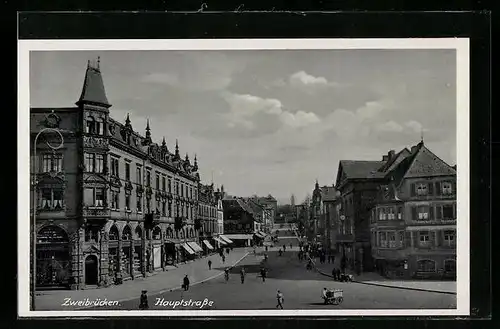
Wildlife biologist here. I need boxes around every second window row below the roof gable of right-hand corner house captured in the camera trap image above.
[371,204,456,222]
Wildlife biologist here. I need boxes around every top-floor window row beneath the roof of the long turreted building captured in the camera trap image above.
[89,153,197,199]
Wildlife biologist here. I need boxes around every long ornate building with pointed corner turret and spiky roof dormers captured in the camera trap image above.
[31,61,201,289]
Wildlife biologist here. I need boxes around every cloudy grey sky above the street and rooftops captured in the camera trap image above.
[30,49,456,203]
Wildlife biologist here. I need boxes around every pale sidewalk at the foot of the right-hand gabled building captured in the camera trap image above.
[314,257,457,294]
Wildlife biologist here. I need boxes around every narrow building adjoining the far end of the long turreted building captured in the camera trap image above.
[195,183,219,253]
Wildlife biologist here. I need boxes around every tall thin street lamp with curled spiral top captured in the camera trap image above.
[31,128,64,311]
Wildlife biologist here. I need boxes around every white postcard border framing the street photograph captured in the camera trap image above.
[17,38,470,317]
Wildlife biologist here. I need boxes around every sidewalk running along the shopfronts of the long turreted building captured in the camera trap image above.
[36,248,251,310]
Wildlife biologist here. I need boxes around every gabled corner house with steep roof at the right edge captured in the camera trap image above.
[370,142,457,277]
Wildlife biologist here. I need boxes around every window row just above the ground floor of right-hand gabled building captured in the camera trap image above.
[372,230,456,248]
